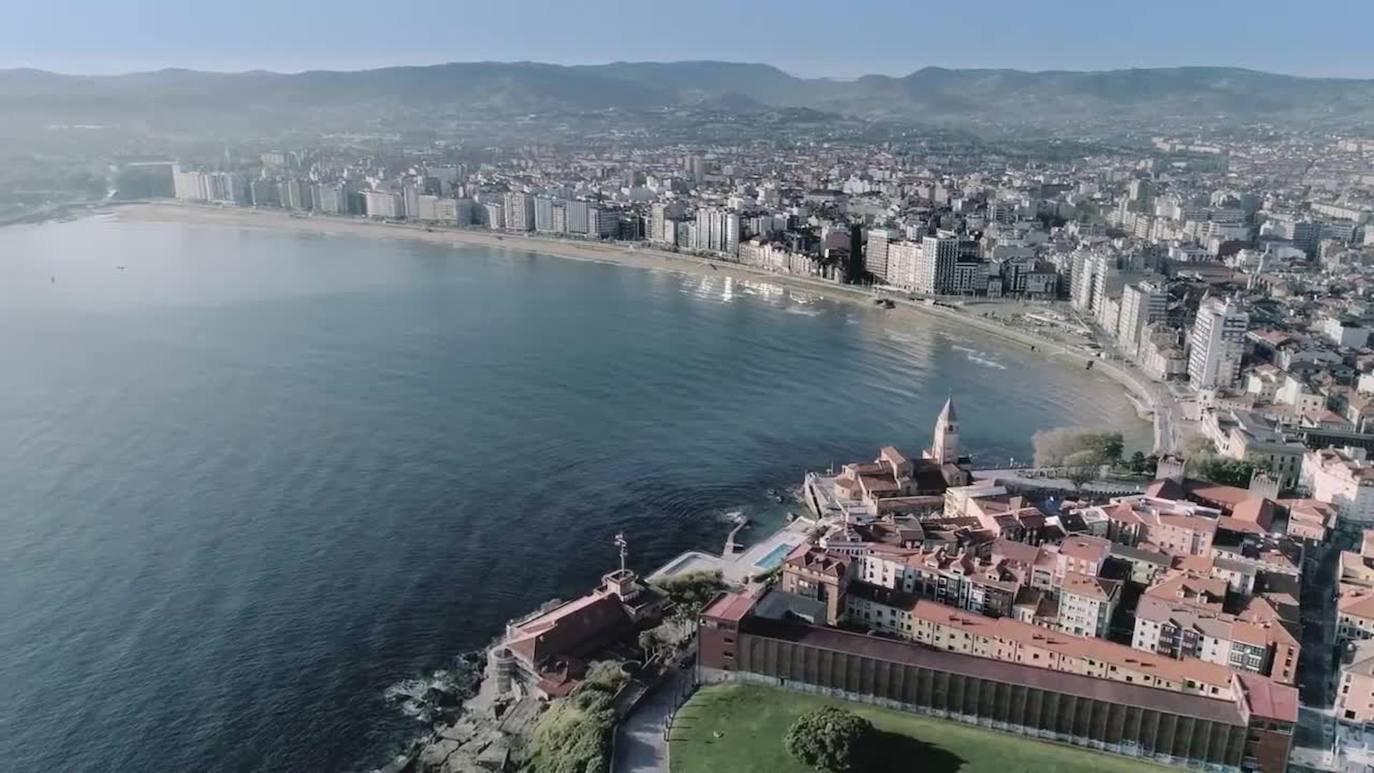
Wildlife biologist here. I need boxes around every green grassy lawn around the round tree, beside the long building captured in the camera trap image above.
[669,685,1164,773]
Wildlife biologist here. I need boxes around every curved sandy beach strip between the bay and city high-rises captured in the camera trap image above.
[107,202,1178,452]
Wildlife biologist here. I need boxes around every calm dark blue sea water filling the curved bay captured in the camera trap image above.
[0,220,1146,770]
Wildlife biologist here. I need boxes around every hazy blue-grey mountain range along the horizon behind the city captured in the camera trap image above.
[0,62,1374,128]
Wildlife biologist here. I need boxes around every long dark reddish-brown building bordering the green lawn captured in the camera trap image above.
[698,590,1297,773]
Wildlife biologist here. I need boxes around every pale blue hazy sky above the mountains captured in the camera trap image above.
[8,0,1374,77]
